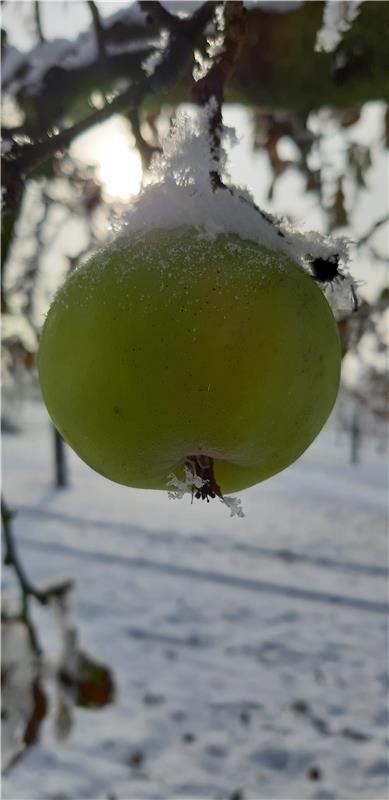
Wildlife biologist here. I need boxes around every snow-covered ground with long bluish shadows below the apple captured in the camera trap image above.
[3,404,388,800]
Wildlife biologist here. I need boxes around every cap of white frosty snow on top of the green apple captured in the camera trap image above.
[101,105,354,311]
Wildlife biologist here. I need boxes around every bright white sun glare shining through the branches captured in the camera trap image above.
[71,116,143,200]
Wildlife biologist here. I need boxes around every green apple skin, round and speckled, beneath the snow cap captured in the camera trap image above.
[38,228,340,494]
